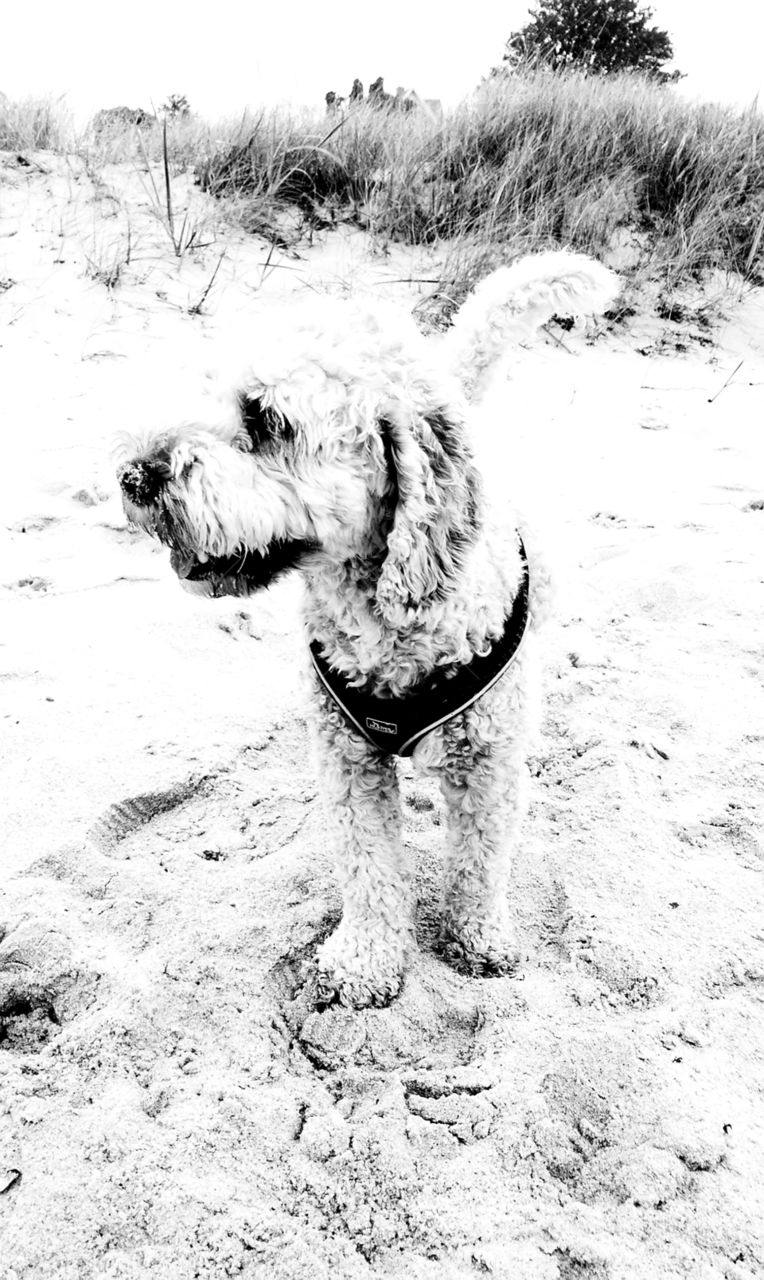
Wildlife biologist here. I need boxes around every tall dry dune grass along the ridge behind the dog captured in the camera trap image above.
[0,68,764,292]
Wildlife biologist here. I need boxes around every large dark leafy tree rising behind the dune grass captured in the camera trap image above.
[497,0,681,83]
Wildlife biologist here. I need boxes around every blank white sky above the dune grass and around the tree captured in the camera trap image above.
[0,0,764,119]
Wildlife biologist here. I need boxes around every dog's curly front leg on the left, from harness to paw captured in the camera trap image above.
[308,701,412,1009]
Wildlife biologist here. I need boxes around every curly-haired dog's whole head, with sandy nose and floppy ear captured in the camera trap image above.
[118,302,480,616]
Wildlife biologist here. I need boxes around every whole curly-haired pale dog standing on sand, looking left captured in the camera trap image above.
[118,252,617,1009]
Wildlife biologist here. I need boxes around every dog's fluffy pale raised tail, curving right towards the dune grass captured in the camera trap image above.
[444,252,619,399]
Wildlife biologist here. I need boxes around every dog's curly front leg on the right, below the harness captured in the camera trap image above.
[442,708,527,975]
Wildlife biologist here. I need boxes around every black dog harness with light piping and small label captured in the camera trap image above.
[310,541,530,755]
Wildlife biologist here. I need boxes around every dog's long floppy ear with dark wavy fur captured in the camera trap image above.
[376,408,481,626]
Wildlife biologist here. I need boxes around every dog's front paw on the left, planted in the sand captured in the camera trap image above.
[316,920,407,1009]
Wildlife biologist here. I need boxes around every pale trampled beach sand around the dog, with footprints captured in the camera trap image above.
[0,154,764,1280]
